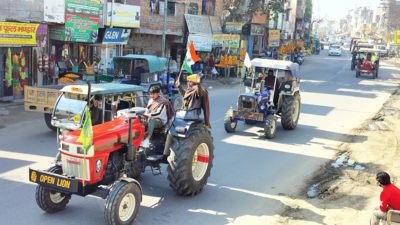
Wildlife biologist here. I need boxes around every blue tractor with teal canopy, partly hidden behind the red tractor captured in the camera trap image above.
[113,54,183,110]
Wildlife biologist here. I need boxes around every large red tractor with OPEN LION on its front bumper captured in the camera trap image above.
[29,81,214,225]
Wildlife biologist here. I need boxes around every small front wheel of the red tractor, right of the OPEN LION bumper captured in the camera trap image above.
[104,181,142,225]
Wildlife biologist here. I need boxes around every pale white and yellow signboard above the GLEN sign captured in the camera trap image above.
[107,1,140,28]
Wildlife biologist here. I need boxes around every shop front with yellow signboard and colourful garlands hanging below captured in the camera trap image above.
[0,22,48,99]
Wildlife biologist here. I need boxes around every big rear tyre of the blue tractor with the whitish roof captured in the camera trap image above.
[281,92,301,130]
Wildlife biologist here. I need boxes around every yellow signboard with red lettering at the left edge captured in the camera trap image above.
[0,22,47,47]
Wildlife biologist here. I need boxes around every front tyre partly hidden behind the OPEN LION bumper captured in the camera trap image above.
[35,166,71,213]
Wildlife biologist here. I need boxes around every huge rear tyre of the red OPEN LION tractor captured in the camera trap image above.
[167,127,214,196]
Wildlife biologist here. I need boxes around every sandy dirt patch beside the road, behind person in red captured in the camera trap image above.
[278,91,400,225]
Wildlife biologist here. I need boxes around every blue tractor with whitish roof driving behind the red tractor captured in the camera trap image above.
[224,58,301,139]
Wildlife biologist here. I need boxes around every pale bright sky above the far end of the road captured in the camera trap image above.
[313,0,381,20]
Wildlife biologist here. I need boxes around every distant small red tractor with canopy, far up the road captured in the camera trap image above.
[356,48,379,79]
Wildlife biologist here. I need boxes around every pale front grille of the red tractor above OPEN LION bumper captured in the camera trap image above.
[61,155,90,180]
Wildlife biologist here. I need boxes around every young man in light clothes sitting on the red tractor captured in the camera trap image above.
[140,86,175,148]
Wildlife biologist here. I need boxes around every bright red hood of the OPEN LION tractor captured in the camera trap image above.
[61,116,144,151]
